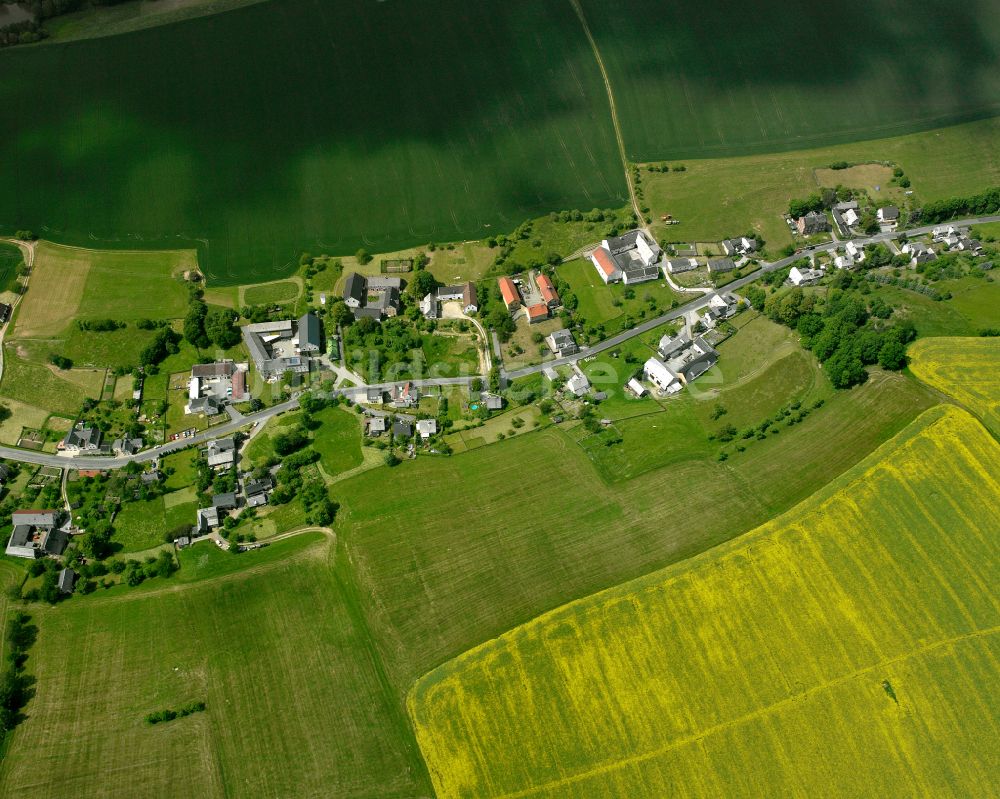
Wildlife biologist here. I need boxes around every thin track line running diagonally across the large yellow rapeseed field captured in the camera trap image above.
[496,625,1000,799]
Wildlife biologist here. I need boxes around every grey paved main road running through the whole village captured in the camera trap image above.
[0,214,1000,469]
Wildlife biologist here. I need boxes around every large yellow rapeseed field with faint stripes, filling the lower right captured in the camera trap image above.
[408,406,1000,799]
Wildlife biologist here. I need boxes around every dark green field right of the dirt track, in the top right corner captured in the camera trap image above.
[581,0,1000,161]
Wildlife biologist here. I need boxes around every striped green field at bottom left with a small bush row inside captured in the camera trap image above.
[0,534,430,799]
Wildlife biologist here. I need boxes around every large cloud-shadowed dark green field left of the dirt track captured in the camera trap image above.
[0,0,625,283]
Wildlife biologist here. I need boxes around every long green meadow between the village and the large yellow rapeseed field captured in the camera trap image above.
[331,374,933,700]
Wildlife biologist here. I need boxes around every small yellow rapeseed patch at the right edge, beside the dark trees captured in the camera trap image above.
[908,337,1000,434]
